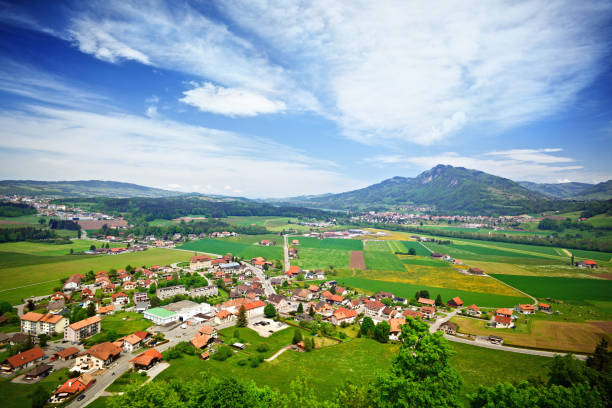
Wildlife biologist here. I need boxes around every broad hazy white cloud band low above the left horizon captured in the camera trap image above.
[0,106,361,197]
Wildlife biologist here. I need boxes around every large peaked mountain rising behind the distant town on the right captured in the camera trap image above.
[288,165,555,214]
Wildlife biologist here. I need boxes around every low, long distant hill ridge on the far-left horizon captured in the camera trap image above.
[0,180,183,198]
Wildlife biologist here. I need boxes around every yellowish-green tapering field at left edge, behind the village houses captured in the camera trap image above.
[0,244,191,304]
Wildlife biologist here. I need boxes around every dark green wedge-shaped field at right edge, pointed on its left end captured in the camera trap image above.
[493,275,612,301]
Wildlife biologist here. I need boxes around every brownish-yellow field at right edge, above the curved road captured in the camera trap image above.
[452,316,612,353]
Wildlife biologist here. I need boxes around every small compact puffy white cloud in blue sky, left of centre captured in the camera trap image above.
[180,82,286,116]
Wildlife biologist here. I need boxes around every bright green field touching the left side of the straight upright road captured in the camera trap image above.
[179,238,283,259]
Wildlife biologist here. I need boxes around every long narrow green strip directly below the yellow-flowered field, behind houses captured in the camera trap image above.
[336,277,530,307]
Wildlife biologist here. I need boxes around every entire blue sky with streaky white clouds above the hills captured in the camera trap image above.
[0,0,612,198]
